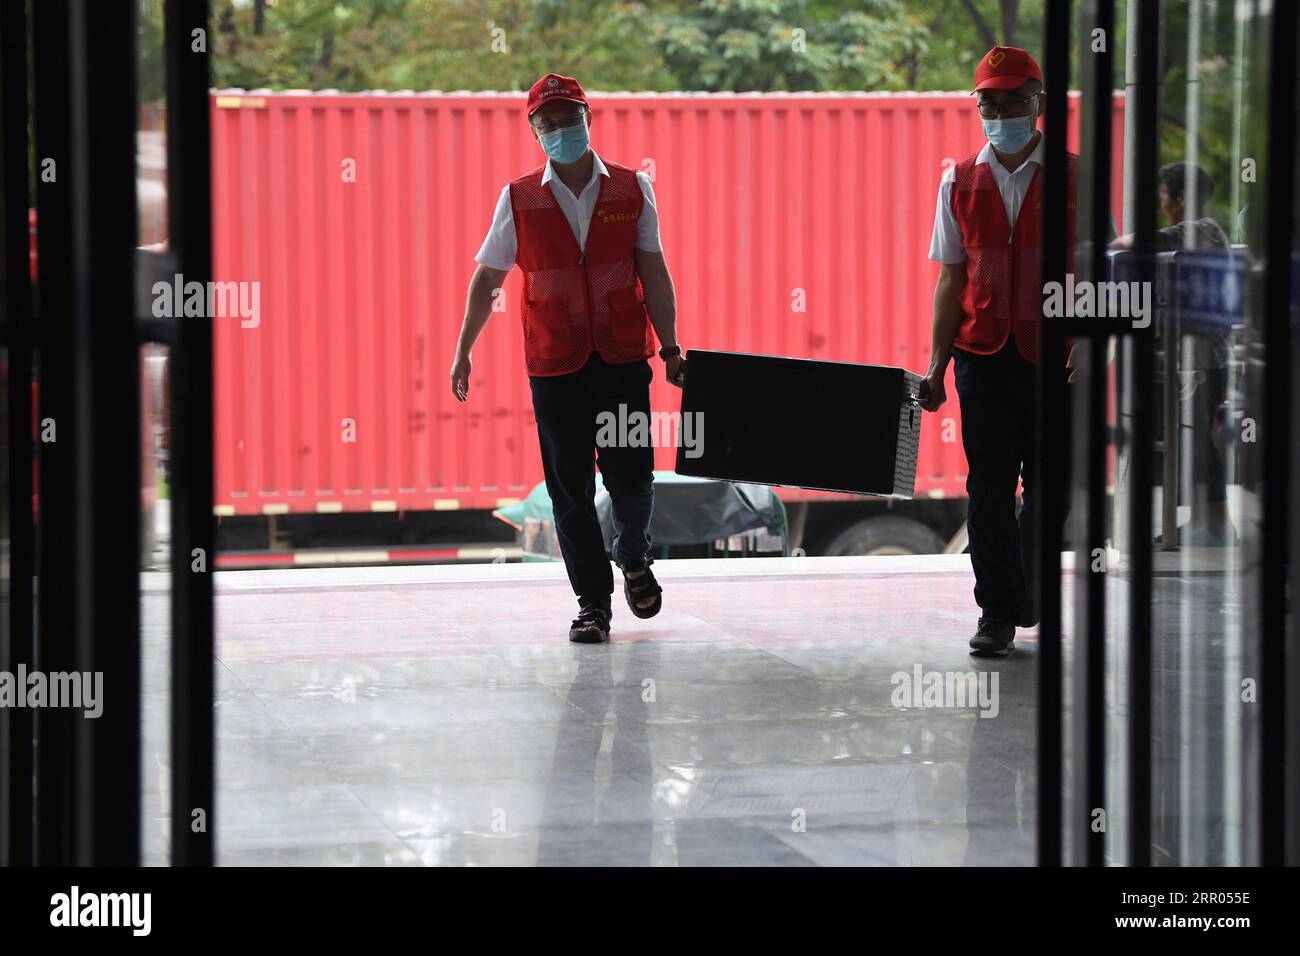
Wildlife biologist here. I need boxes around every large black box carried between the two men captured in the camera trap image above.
[676,349,920,498]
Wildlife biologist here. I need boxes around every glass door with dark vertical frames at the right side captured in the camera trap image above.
[1040,0,1296,866]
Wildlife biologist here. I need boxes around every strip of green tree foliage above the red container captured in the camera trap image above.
[213,0,951,91]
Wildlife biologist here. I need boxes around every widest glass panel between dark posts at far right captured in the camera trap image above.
[1147,0,1269,866]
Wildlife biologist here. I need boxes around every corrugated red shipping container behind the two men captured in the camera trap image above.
[212,91,1123,515]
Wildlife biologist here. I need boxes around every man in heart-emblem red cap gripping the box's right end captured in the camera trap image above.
[920,47,1078,656]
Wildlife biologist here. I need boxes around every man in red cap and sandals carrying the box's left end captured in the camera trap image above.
[451,73,684,644]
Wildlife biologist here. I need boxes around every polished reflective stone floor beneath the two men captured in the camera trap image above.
[146,555,1036,865]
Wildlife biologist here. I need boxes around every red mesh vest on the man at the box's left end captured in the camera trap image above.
[510,163,654,376]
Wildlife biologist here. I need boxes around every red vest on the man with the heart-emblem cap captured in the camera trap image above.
[953,153,1079,362]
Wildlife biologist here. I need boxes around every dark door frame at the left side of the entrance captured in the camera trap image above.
[0,0,215,865]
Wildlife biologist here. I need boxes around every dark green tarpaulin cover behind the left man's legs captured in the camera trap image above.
[493,471,785,561]
